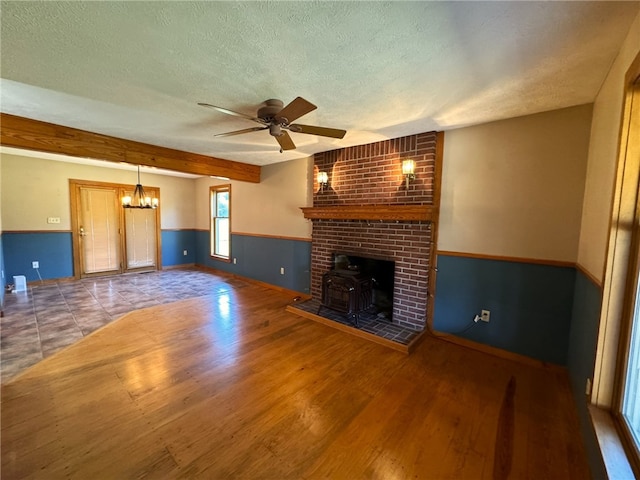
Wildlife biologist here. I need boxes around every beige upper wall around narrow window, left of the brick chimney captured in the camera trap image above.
[196,157,313,239]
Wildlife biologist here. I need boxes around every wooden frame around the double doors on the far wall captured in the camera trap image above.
[69,179,162,280]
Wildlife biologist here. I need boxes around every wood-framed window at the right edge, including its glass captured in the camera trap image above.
[591,63,640,478]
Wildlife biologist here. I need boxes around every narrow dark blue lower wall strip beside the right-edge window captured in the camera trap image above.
[567,270,607,478]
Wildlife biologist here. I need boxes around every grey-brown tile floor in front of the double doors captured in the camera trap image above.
[0,268,247,383]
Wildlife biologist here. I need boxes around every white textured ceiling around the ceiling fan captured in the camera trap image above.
[0,0,640,165]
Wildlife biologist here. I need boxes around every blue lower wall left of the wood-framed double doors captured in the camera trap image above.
[2,232,73,283]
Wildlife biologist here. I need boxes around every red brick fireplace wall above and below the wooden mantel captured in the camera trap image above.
[311,132,436,330]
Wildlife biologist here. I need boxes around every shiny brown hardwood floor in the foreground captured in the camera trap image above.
[1,285,589,479]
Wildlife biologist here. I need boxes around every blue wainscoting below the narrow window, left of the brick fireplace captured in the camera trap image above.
[196,230,311,294]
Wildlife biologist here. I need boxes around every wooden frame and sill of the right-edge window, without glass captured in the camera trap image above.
[590,50,640,478]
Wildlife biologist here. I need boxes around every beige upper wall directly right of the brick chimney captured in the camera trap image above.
[438,105,592,262]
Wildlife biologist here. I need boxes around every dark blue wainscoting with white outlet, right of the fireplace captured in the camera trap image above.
[433,254,576,365]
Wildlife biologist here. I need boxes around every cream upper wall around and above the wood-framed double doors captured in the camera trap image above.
[0,154,195,231]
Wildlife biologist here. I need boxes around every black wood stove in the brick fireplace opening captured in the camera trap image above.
[318,270,373,327]
